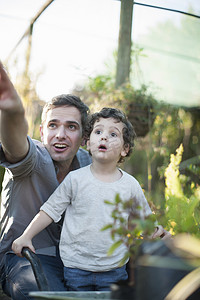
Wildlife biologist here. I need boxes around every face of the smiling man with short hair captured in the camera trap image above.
[40,106,82,163]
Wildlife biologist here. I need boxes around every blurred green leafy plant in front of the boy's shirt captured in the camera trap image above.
[102,194,156,265]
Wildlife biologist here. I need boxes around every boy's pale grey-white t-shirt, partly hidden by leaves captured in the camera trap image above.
[41,166,151,272]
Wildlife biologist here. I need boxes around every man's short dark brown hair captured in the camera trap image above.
[42,94,89,134]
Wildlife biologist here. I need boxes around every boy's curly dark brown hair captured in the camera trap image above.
[85,107,136,162]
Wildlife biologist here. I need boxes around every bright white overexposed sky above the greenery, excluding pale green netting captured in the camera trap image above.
[0,0,200,105]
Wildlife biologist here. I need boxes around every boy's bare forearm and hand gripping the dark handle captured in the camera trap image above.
[12,210,53,257]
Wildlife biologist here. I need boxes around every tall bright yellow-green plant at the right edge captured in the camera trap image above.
[165,144,200,237]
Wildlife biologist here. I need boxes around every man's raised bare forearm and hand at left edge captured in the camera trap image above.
[0,62,29,163]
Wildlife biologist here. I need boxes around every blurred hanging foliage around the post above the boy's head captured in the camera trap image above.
[84,75,160,136]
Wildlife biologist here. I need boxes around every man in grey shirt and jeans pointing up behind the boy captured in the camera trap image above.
[0,64,91,300]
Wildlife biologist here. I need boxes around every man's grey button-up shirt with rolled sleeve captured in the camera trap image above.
[0,137,91,261]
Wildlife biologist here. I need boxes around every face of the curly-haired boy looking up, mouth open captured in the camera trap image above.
[87,118,128,163]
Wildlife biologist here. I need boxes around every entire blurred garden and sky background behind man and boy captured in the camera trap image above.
[0,0,200,232]
